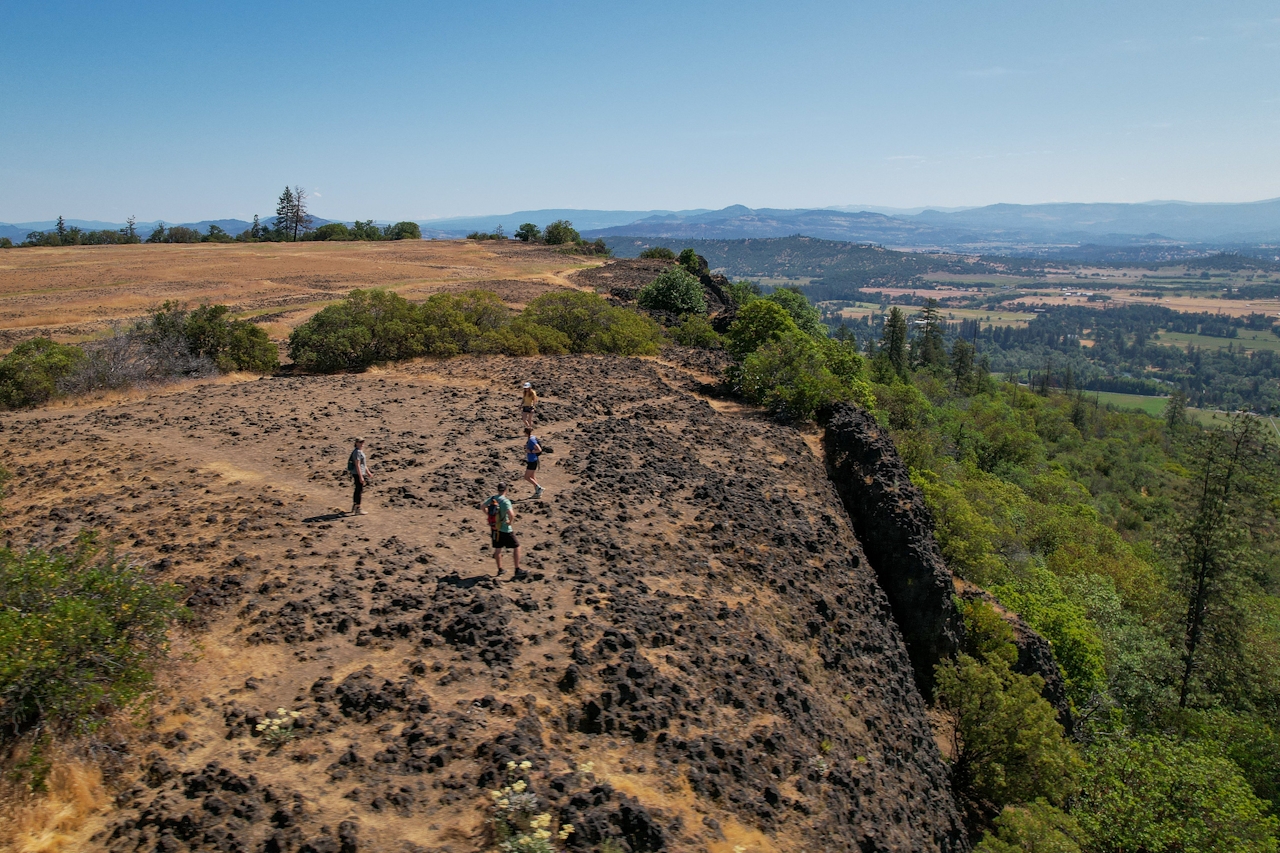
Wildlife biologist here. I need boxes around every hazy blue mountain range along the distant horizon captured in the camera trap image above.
[10,199,1280,254]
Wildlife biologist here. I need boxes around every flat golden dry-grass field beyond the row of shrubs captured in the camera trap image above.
[0,241,600,350]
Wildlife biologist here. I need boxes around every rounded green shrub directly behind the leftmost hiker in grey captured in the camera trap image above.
[289,289,428,373]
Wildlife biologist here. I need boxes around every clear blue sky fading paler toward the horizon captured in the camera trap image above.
[0,0,1280,222]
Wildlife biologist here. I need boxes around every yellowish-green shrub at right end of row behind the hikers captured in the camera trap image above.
[521,291,662,355]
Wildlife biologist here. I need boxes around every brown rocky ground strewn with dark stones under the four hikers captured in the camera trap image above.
[0,356,964,853]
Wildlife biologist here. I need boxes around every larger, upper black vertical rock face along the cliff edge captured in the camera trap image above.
[823,406,964,697]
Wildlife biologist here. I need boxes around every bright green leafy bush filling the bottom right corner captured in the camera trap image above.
[1071,738,1280,853]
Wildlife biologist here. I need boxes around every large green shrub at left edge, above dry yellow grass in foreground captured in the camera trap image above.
[0,538,186,740]
